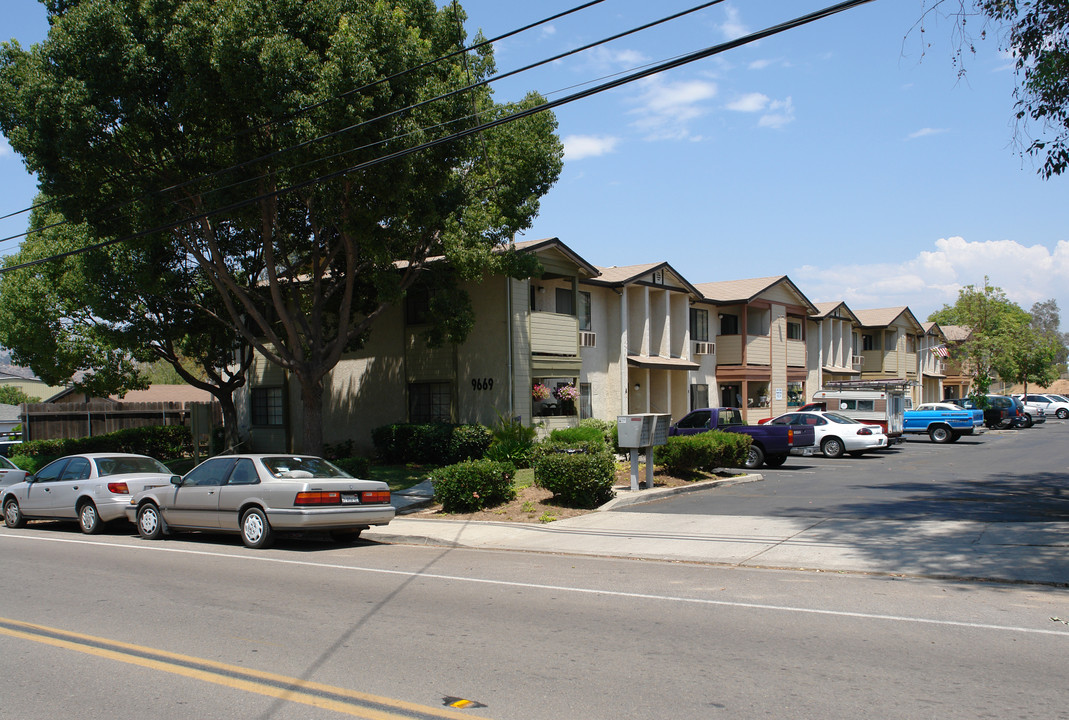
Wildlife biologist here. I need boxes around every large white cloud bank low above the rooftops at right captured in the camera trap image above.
[790,237,1069,325]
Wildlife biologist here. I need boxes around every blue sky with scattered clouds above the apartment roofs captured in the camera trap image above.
[0,0,1069,329]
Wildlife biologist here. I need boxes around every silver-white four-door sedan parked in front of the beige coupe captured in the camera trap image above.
[2,453,174,534]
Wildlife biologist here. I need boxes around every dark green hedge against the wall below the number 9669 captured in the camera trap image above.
[371,423,492,465]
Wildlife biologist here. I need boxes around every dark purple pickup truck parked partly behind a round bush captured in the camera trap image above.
[668,407,817,470]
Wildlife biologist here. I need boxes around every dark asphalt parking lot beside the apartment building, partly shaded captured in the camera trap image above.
[615,420,1069,522]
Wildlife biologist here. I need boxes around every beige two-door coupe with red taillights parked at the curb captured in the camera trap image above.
[126,455,396,548]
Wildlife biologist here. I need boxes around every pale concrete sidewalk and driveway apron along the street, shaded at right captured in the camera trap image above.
[362,475,1069,584]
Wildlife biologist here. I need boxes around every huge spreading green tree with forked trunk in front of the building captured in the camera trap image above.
[0,0,562,452]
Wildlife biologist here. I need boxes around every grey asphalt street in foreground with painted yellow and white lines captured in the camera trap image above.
[0,525,1069,720]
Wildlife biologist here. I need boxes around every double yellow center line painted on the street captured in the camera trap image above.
[0,617,487,720]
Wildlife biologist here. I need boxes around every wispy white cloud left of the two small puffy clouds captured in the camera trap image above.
[630,75,716,140]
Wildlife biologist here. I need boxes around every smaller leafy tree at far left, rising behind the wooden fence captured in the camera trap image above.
[0,198,252,447]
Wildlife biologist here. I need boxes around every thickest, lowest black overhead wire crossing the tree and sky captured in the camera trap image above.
[0,0,873,275]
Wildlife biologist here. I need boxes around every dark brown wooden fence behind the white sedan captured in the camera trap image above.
[22,401,222,440]
